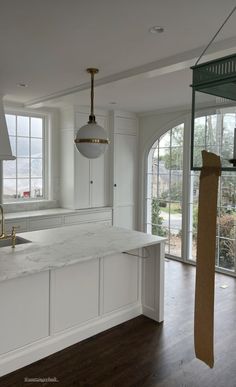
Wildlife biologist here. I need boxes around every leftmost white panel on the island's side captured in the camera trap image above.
[0,272,49,355]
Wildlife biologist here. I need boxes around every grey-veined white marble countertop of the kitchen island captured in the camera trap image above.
[0,224,166,281]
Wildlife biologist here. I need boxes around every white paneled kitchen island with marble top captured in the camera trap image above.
[0,224,165,376]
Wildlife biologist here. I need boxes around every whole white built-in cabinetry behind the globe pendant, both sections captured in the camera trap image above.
[60,107,138,229]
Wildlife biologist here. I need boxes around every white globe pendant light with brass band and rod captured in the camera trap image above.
[75,68,110,159]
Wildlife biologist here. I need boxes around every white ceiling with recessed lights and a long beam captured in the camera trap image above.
[0,0,236,112]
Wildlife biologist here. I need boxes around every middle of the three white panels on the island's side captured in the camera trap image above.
[51,259,99,332]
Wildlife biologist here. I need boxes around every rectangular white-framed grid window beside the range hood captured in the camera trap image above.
[3,114,45,203]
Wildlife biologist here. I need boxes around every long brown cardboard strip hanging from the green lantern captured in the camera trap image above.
[194,151,221,368]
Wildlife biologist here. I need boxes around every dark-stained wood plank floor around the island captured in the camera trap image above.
[0,261,236,387]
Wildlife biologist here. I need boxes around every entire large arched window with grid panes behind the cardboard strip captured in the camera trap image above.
[146,108,236,274]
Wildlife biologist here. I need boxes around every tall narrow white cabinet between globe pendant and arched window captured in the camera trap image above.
[111,112,138,229]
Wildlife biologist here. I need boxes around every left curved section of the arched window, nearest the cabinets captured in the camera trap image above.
[147,124,184,257]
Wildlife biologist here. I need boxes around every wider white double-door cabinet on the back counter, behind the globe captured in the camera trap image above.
[61,108,110,209]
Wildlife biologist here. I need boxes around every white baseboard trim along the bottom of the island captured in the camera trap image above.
[0,303,142,376]
